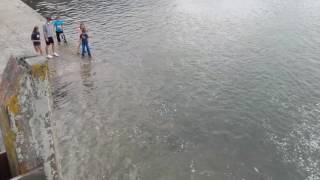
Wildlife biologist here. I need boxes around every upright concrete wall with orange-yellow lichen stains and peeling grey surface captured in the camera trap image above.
[0,57,56,179]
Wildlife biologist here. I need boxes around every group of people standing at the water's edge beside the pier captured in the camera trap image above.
[31,16,91,59]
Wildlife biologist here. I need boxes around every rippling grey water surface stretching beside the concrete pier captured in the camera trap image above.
[21,0,320,180]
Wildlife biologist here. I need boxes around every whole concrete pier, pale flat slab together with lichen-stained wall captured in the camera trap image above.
[0,0,63,179]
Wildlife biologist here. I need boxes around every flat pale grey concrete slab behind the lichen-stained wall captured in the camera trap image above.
[0,0,44,75]
